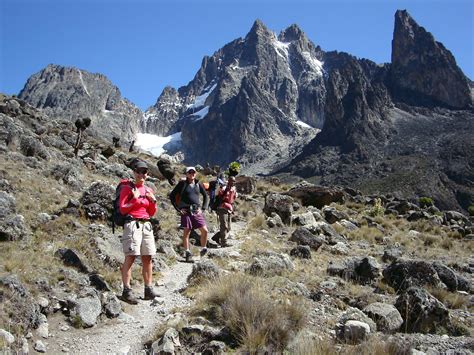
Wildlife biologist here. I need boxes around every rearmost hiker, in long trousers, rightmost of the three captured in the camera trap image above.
[217,176,237,247]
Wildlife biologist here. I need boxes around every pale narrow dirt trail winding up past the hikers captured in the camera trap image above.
[44,222,245,354]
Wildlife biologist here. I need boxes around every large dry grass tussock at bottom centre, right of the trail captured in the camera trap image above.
[196,274,306,353]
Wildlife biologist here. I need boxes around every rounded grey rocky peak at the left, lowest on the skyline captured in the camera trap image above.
[19,64,143,142]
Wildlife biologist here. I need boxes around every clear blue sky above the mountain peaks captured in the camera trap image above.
[0,0,474,109]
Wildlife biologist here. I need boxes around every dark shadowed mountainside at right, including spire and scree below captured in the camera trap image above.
[281,11,474,209]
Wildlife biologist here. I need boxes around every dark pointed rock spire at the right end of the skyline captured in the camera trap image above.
[391,10,472,108]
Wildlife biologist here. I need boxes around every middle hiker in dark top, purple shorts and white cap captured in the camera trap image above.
[170,166,209,262]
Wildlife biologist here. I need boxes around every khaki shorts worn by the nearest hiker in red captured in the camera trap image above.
[122,221,156,255]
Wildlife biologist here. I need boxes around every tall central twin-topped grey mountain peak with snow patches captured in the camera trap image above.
[143,20,326,172]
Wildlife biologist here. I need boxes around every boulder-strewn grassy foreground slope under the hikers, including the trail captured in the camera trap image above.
[0,96,474,354]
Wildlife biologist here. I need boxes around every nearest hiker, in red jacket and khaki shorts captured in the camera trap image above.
[119,161,158,304]
